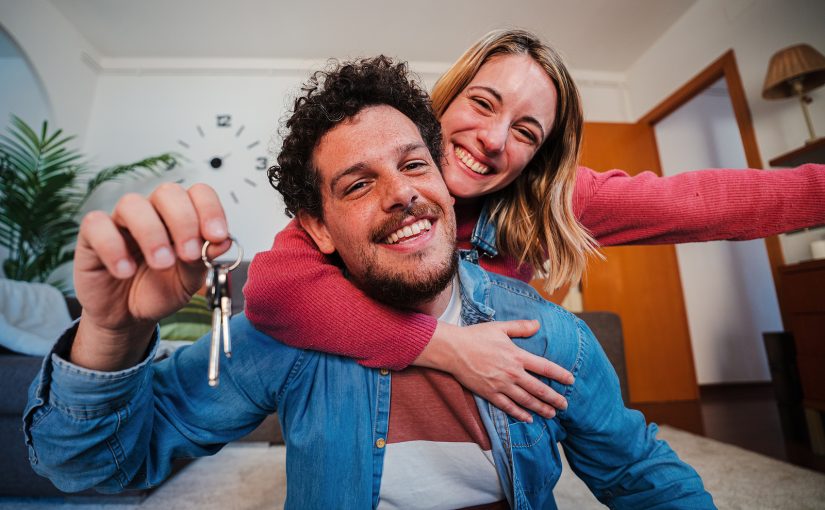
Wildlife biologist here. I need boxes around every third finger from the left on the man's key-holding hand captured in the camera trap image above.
[149,182,203,262]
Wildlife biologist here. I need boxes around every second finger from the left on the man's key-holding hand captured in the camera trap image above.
[112,193,177,270]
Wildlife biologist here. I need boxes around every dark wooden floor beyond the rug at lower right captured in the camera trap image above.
[631,383,825,473]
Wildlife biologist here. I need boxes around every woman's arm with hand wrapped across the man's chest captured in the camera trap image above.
[244,221,572,420]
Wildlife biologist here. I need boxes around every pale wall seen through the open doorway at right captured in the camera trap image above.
[655,81,782,384]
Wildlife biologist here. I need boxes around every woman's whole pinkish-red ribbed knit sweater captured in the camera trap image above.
[244,165,825,369]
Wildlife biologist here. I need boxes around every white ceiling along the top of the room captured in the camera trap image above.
[50,0,696,72]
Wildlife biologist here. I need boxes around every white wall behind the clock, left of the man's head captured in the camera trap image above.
[85,65,306,259]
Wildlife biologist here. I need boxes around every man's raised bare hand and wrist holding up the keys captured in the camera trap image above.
[71,183,231,371]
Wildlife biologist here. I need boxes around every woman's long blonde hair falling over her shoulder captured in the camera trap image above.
[431,30,597,288]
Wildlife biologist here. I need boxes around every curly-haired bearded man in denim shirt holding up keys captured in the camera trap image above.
[24,58,713,508]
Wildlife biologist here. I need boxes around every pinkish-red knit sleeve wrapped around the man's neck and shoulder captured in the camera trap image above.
[243,217,437,370]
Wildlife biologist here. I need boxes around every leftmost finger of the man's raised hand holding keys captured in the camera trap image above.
[77,211,137,279]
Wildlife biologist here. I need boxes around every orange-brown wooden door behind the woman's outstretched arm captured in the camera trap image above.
[582,122,698,403]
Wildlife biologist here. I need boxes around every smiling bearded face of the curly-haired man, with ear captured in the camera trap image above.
[299,106,455,307]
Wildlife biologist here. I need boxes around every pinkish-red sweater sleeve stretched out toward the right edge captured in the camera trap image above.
[573,164,825,246]
